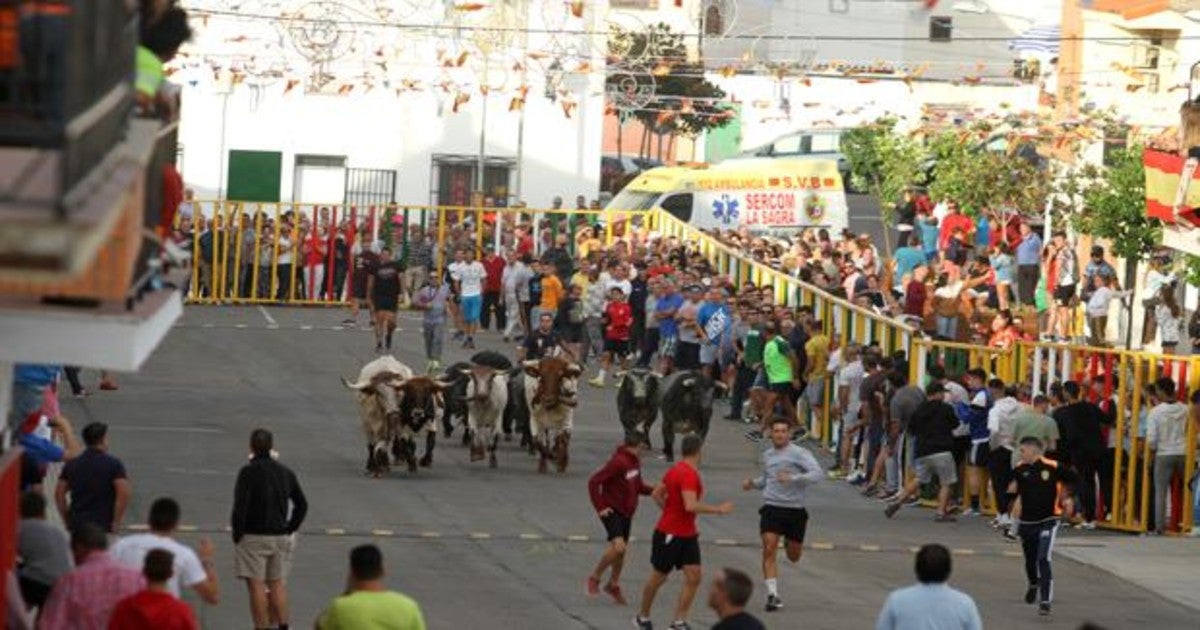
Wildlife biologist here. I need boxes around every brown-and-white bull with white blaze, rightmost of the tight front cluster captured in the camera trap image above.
[523,356,583,473]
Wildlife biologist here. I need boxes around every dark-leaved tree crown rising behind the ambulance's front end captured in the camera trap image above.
[606,23,732,137]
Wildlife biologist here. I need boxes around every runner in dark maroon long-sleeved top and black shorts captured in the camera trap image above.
[587,432,654,606]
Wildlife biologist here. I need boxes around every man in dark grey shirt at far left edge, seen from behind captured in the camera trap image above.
[17,492,71,608]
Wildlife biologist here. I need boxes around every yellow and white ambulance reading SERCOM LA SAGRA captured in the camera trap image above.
[606,158,850,234]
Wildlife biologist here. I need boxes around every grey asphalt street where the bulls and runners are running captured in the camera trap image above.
[64,306,1196,630]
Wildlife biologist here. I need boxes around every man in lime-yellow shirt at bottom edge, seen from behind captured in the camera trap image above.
[317,545,425,630]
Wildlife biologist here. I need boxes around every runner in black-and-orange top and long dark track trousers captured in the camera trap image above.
[1008,437,1078,616]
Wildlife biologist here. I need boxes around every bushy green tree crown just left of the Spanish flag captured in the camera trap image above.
[1067,145,1163,260]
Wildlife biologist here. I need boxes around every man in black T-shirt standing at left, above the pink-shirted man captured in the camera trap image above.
[54,422,132,532]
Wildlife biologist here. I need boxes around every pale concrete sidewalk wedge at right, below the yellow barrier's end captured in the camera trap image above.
[1055,536,1200,611]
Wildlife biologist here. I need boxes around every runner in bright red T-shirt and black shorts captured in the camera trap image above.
[634,433,733,630]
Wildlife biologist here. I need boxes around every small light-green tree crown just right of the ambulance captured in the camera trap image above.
[840,118,925,224]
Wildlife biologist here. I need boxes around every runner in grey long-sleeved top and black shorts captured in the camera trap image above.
[742,419,824,612]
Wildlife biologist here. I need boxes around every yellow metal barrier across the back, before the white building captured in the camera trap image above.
[175,200,644,305]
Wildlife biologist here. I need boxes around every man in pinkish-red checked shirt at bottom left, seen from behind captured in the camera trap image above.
[38,522,145,630]
